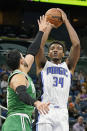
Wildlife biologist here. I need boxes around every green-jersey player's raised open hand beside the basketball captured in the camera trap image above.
[38,15,50,32]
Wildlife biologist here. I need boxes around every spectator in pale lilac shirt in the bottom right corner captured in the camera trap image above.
[73,116,85,131]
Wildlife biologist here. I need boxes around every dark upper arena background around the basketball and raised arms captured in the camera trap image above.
[0,0,87,55]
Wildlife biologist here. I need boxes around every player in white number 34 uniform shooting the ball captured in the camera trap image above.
[36,8,80,131]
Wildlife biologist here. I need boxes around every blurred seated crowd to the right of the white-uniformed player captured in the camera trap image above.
[68,71,87,131]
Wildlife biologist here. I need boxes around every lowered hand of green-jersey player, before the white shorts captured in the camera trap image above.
[34,101,50,114]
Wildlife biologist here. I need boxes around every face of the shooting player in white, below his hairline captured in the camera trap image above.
[48,43,64,60]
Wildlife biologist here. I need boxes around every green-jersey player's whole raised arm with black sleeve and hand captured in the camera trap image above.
[25,16,48,71]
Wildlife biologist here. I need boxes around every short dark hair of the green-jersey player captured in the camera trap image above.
[6,49,21,70]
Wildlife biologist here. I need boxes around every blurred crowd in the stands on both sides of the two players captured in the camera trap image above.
[0,64,87,131]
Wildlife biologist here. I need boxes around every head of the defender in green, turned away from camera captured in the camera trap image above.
[7,49,28,70]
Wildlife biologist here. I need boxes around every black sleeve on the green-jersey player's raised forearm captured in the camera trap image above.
[27,31,44,56]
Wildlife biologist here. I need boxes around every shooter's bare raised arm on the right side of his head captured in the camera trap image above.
[58,9,80,74]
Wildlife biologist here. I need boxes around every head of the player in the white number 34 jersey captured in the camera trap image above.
[48,41,65,61]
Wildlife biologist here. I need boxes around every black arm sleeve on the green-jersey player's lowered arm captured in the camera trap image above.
[16,85,36,106]
